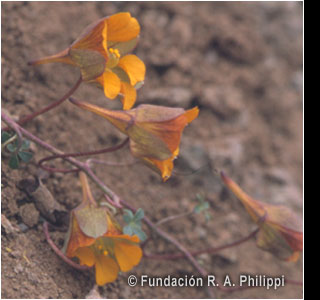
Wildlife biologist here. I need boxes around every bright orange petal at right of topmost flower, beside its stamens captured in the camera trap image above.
[118,54,146,86]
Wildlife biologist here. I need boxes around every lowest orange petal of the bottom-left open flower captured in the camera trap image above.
[95,254,119,285]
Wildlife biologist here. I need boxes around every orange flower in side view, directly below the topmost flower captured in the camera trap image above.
[70,99,199,181]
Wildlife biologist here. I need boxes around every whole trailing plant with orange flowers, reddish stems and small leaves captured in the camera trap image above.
[2,12,303,298]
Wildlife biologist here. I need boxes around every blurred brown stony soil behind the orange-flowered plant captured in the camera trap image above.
[1,2,303,298]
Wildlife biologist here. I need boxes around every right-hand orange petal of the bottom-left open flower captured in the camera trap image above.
[114,239,142,272]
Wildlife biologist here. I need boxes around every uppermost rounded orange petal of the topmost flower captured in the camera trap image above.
[107,13,140,42]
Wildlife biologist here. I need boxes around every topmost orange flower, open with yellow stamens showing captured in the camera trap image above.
[30,12,146,109]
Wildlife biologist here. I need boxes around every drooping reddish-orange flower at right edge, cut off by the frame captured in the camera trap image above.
[221,172,303,261]
